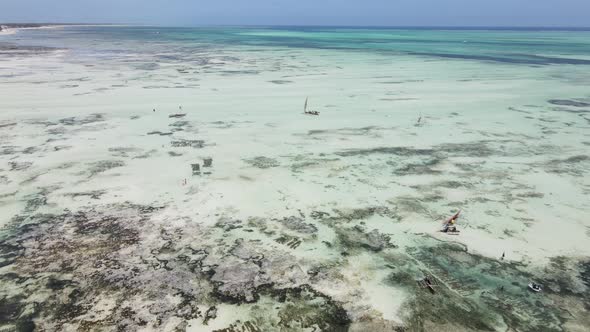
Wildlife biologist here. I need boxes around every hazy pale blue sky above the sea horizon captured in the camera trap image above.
[0,0,590,27]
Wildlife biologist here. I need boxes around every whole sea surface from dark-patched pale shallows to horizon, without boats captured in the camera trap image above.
[0,27,590,331]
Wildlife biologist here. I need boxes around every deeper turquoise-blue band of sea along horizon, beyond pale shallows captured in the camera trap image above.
[5,27,590,65]
